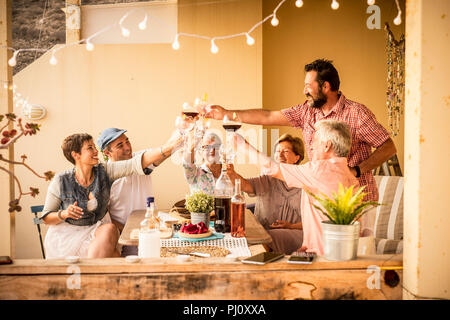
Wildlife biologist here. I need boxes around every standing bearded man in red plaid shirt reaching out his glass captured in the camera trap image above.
[205,59,397,201]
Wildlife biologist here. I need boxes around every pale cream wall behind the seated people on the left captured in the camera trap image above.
[11,0,262,258]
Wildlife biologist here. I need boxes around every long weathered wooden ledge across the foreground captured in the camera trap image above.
[0,255,403,300]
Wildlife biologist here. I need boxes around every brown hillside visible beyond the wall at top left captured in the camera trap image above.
[12,0,149,74]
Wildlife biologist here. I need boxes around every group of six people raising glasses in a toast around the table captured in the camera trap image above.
[42,59,396,258]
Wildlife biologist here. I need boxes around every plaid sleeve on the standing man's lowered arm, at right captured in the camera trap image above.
[356,107,390,148]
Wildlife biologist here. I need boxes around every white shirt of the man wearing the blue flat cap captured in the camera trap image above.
[109,149,155,225]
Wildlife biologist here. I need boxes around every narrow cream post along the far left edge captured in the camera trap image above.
[0,0,15,257]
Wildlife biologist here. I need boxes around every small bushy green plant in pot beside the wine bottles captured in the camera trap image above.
[185,191,214,227]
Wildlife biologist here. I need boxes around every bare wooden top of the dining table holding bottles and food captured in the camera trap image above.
[119,209,272,246]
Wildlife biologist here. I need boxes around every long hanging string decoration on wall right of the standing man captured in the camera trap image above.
[384,23,405,137]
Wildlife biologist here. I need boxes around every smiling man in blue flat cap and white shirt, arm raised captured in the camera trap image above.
[97,128,182,256]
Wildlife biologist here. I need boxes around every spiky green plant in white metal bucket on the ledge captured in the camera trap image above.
[307,184,380,261]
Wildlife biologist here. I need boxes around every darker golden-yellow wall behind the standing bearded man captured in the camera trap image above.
[263,0,405,168]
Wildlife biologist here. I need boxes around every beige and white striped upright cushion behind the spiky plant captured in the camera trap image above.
[374,176,404,240]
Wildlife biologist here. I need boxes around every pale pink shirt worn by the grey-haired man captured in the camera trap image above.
[280,158,359,255]
